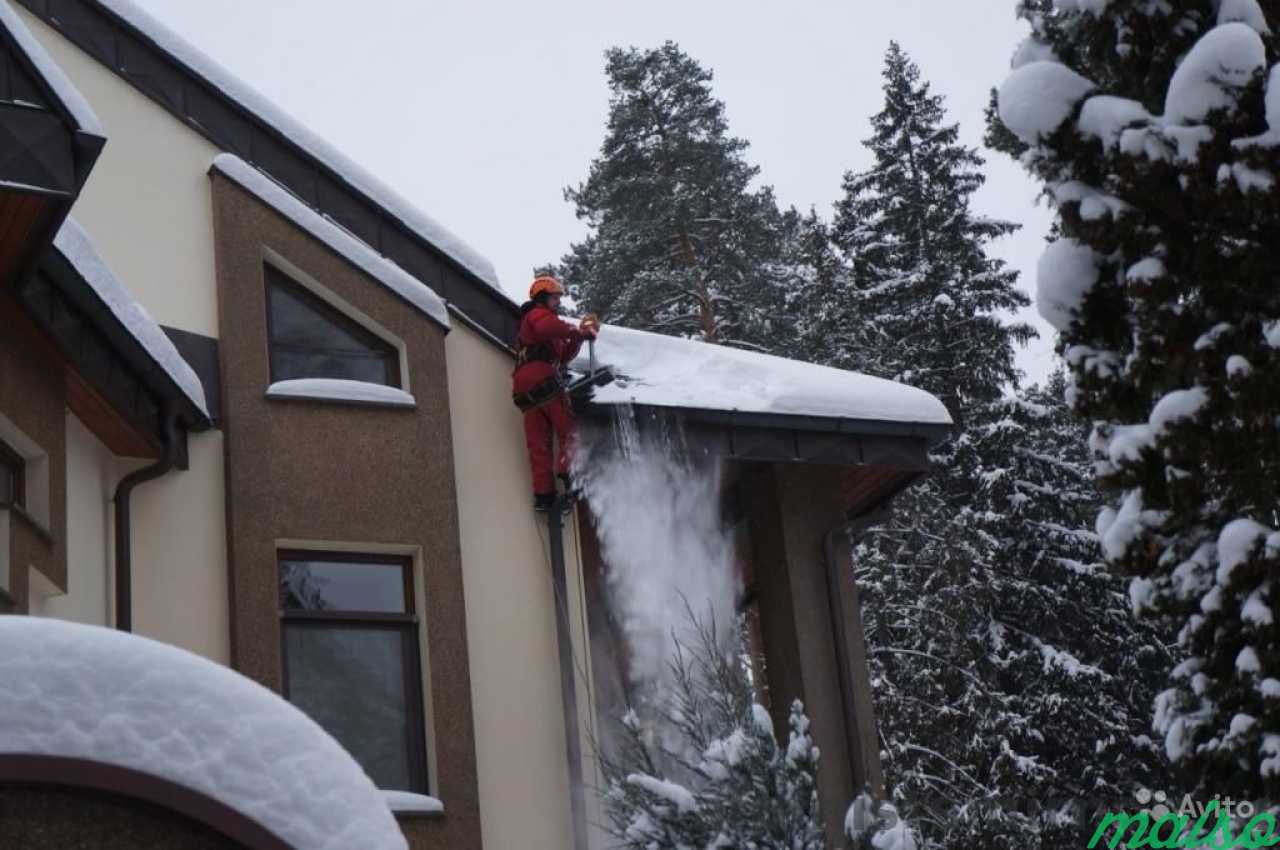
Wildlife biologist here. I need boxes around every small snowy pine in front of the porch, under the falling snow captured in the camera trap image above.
[602,614,826,850]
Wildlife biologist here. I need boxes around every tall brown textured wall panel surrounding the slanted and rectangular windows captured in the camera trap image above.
[211,173,480,850]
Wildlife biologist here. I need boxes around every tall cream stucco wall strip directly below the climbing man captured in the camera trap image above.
[445,323,596,850]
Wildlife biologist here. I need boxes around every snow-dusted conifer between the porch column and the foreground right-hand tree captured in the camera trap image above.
[855,376,1169,850]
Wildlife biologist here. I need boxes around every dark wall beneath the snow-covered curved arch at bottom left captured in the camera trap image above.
[0,787,243,850]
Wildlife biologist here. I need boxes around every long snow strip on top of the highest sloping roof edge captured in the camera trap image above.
[93,0,506,297]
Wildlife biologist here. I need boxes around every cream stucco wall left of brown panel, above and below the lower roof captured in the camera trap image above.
[19,8,230,663]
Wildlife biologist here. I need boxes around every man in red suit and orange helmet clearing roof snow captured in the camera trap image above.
[511,275,600,511]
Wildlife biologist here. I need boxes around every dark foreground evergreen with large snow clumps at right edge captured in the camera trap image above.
[992,0,1280,800]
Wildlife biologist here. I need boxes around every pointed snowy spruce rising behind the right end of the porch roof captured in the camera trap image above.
[805,44,1033,416]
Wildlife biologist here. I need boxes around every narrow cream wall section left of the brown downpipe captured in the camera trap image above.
[31,412,115,626]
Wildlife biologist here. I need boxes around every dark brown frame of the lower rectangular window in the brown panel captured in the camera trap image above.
[275,549,431,794]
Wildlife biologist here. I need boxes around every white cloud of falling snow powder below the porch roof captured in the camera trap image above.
[577,408,737,696]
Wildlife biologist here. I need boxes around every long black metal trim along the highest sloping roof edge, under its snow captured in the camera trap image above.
[17,0,518,347]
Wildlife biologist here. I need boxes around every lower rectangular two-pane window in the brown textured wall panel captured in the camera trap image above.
[279,552,428,794]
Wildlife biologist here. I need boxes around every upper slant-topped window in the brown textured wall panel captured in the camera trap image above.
[265,265,401,388]
